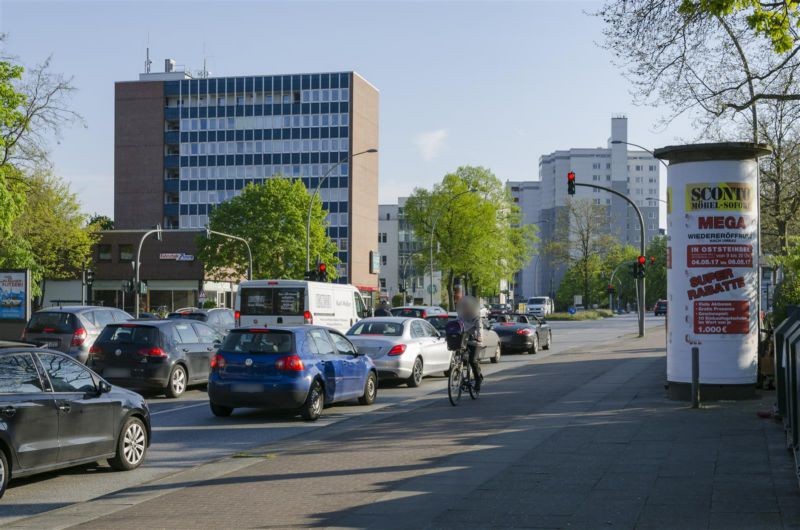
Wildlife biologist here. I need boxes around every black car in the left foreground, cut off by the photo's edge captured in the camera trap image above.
[0,343,150,497]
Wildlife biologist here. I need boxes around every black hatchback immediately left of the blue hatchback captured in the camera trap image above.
[89,320,222,398]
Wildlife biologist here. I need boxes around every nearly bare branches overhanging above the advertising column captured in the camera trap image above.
[597,0,800,142]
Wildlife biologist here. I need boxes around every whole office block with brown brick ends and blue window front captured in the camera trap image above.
[114,65,379,287]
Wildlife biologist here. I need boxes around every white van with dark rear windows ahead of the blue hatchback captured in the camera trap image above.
[235,280,369,333]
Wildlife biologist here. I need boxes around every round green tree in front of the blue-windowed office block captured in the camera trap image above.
[197,177,339,280]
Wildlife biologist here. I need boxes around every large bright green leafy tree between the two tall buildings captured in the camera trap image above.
[405,166,537,306]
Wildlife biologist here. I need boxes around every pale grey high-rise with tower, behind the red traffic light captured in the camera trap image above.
[507,116,661,300]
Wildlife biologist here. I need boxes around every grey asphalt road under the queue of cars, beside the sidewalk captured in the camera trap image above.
[0,314,664,526]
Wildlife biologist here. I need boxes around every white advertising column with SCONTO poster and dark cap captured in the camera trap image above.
[655,143,769,400]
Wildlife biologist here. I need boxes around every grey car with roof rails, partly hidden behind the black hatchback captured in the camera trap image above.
[22,306,133,364]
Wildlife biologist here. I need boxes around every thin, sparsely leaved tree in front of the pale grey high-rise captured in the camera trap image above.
[545,199,617,307]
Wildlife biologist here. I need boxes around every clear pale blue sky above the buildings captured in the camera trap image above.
[0,0,694,216]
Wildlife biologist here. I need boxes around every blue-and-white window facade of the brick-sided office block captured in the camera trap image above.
[164,72,352,282]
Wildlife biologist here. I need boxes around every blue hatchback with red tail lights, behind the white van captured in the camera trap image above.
[208,326,378,421]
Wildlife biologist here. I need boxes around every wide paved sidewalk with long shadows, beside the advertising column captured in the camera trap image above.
[12,328,800,529]
